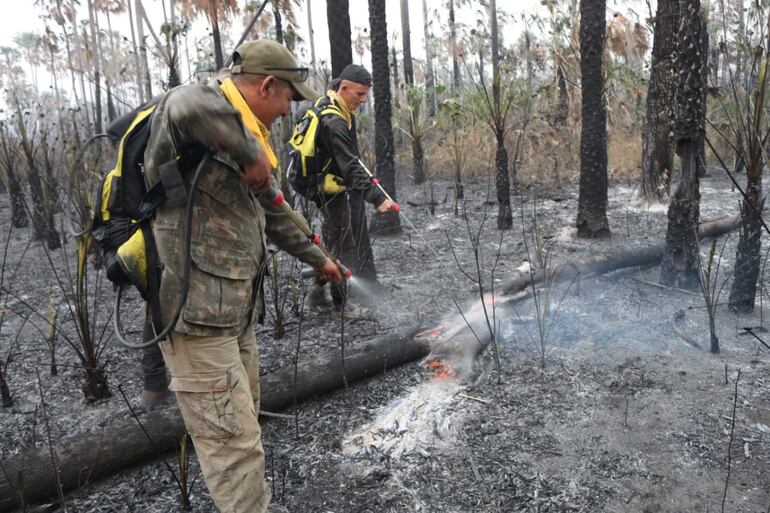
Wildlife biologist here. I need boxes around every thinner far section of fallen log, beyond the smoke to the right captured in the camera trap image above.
[497,217,740,295]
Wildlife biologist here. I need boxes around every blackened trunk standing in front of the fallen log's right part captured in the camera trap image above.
[660,0,707,289]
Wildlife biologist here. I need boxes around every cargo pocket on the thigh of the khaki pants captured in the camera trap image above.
[169,371,243,439]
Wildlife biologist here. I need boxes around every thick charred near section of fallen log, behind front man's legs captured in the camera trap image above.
[0,329,429,511]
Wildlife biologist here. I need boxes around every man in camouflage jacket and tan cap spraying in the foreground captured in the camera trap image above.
[145,40,341,513]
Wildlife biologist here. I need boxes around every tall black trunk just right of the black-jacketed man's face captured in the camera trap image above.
[369,0,401,233]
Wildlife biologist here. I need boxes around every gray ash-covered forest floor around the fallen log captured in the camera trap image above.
[0,172,770,513]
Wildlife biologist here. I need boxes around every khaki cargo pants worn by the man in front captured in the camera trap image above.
[161,325,270,513]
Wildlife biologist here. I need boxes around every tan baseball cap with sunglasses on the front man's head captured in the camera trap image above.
[230,39,321,102]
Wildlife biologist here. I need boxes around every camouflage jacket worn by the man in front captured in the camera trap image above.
[145,81,325,336]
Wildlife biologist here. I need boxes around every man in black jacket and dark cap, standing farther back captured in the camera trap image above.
[308,64,395,318]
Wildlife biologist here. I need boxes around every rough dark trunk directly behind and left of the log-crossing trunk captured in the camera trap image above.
[641,0,679,202]
